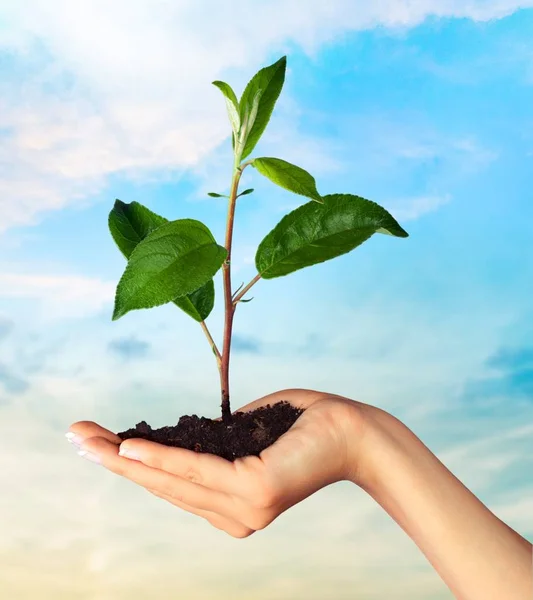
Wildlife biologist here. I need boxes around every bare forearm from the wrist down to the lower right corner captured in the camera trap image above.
[356,409,533,600]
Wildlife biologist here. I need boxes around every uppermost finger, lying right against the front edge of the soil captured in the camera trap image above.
[120,438,243,494]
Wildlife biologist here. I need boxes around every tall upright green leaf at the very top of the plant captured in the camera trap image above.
[239,56,287,159]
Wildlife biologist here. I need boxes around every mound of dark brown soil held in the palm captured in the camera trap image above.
[117,401,305,462]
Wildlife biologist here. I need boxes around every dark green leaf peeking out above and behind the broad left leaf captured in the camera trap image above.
[108,200,168,258]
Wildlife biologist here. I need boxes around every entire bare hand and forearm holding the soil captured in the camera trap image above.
[70,389,533,600]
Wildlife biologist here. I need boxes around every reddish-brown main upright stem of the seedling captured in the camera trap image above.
[220,163,249,425]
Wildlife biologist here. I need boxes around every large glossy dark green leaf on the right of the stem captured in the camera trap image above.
[255,194,409,279]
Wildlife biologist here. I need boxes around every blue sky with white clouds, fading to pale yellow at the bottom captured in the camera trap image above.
[0,0,533,600]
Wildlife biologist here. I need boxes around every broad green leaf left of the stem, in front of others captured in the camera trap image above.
[113,219,227,320]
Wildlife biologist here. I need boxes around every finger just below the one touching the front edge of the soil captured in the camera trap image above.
[81,437,231,513]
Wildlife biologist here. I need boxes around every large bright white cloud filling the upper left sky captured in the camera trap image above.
[0,0,533,231]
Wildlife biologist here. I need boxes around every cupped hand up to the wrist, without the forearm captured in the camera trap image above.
[70,389,372,538]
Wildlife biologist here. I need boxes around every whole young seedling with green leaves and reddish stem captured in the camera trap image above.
[109,57,408,456]
